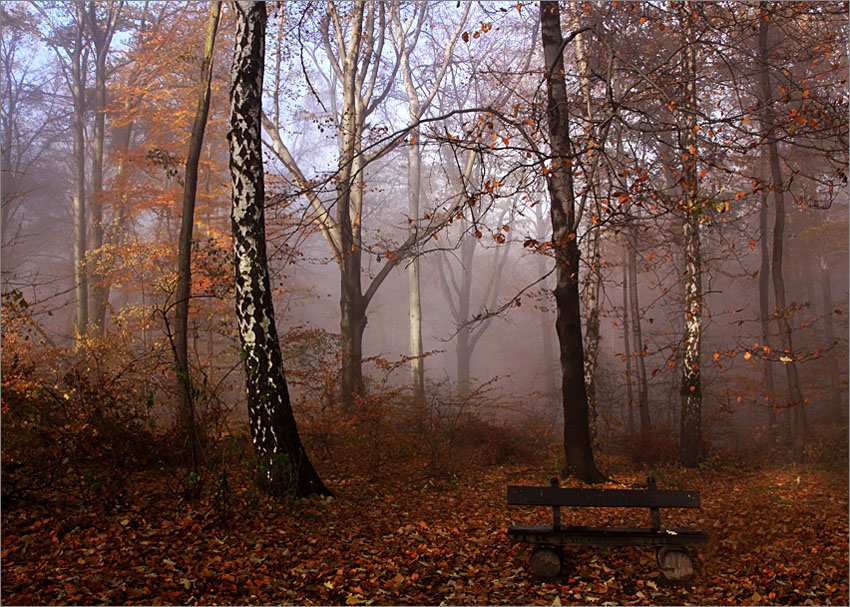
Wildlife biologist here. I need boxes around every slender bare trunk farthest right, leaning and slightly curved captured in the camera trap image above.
[759,2,807,462]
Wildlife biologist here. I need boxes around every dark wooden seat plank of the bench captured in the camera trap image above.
[508,525,709,546]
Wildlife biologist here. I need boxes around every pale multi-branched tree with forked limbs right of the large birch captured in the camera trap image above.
[263,2,476,405]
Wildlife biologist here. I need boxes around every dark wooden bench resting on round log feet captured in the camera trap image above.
[507,478,708,580]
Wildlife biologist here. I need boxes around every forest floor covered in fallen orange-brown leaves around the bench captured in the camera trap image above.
[2,462,848,605]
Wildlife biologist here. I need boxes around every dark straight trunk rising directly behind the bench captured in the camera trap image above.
[540,1,606,483]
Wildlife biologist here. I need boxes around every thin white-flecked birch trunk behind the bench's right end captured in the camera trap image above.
[679,2,703,468]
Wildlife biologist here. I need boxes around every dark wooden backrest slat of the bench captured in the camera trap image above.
[508,485,700,508]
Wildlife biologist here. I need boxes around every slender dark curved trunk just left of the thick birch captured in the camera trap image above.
[174,1,221,467]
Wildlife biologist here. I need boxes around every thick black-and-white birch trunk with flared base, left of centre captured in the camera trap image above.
[228,2,330,497]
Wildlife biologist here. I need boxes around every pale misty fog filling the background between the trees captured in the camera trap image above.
[2,3,850,466]
